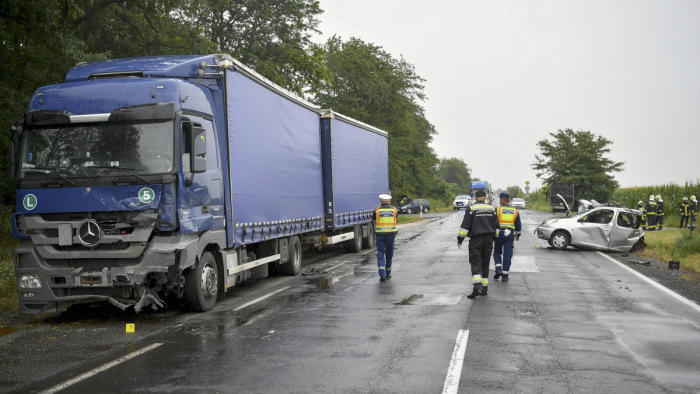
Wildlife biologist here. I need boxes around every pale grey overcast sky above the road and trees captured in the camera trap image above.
[317,0,700,188]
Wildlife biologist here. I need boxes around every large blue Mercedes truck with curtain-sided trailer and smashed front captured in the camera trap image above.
[12,55,389,314]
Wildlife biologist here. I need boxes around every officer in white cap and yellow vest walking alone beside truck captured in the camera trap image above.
[372,194,399,282]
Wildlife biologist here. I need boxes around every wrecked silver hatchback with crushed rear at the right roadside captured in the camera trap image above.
[535,207,646,252]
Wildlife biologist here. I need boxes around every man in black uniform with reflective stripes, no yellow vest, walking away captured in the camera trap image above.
[457,190,500,298]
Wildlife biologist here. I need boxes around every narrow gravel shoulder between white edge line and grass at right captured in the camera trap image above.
[608,253,700,304]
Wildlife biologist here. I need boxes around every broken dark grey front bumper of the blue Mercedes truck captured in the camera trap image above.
[15,235,198,314]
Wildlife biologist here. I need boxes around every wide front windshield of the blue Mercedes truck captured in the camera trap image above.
[20,120,174,179]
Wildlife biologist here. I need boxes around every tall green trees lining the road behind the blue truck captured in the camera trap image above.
[0,0,476,204]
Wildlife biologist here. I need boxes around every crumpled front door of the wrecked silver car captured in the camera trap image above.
[571,208,615,250]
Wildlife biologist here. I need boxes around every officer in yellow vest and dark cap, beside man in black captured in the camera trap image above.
[493,193,521,282]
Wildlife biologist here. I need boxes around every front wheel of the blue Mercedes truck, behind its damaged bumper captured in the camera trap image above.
[185,252,219,312]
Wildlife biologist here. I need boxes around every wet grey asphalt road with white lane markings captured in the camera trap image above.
[0,211,700,393]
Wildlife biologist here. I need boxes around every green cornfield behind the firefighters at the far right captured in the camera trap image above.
[610,179,700,216]
